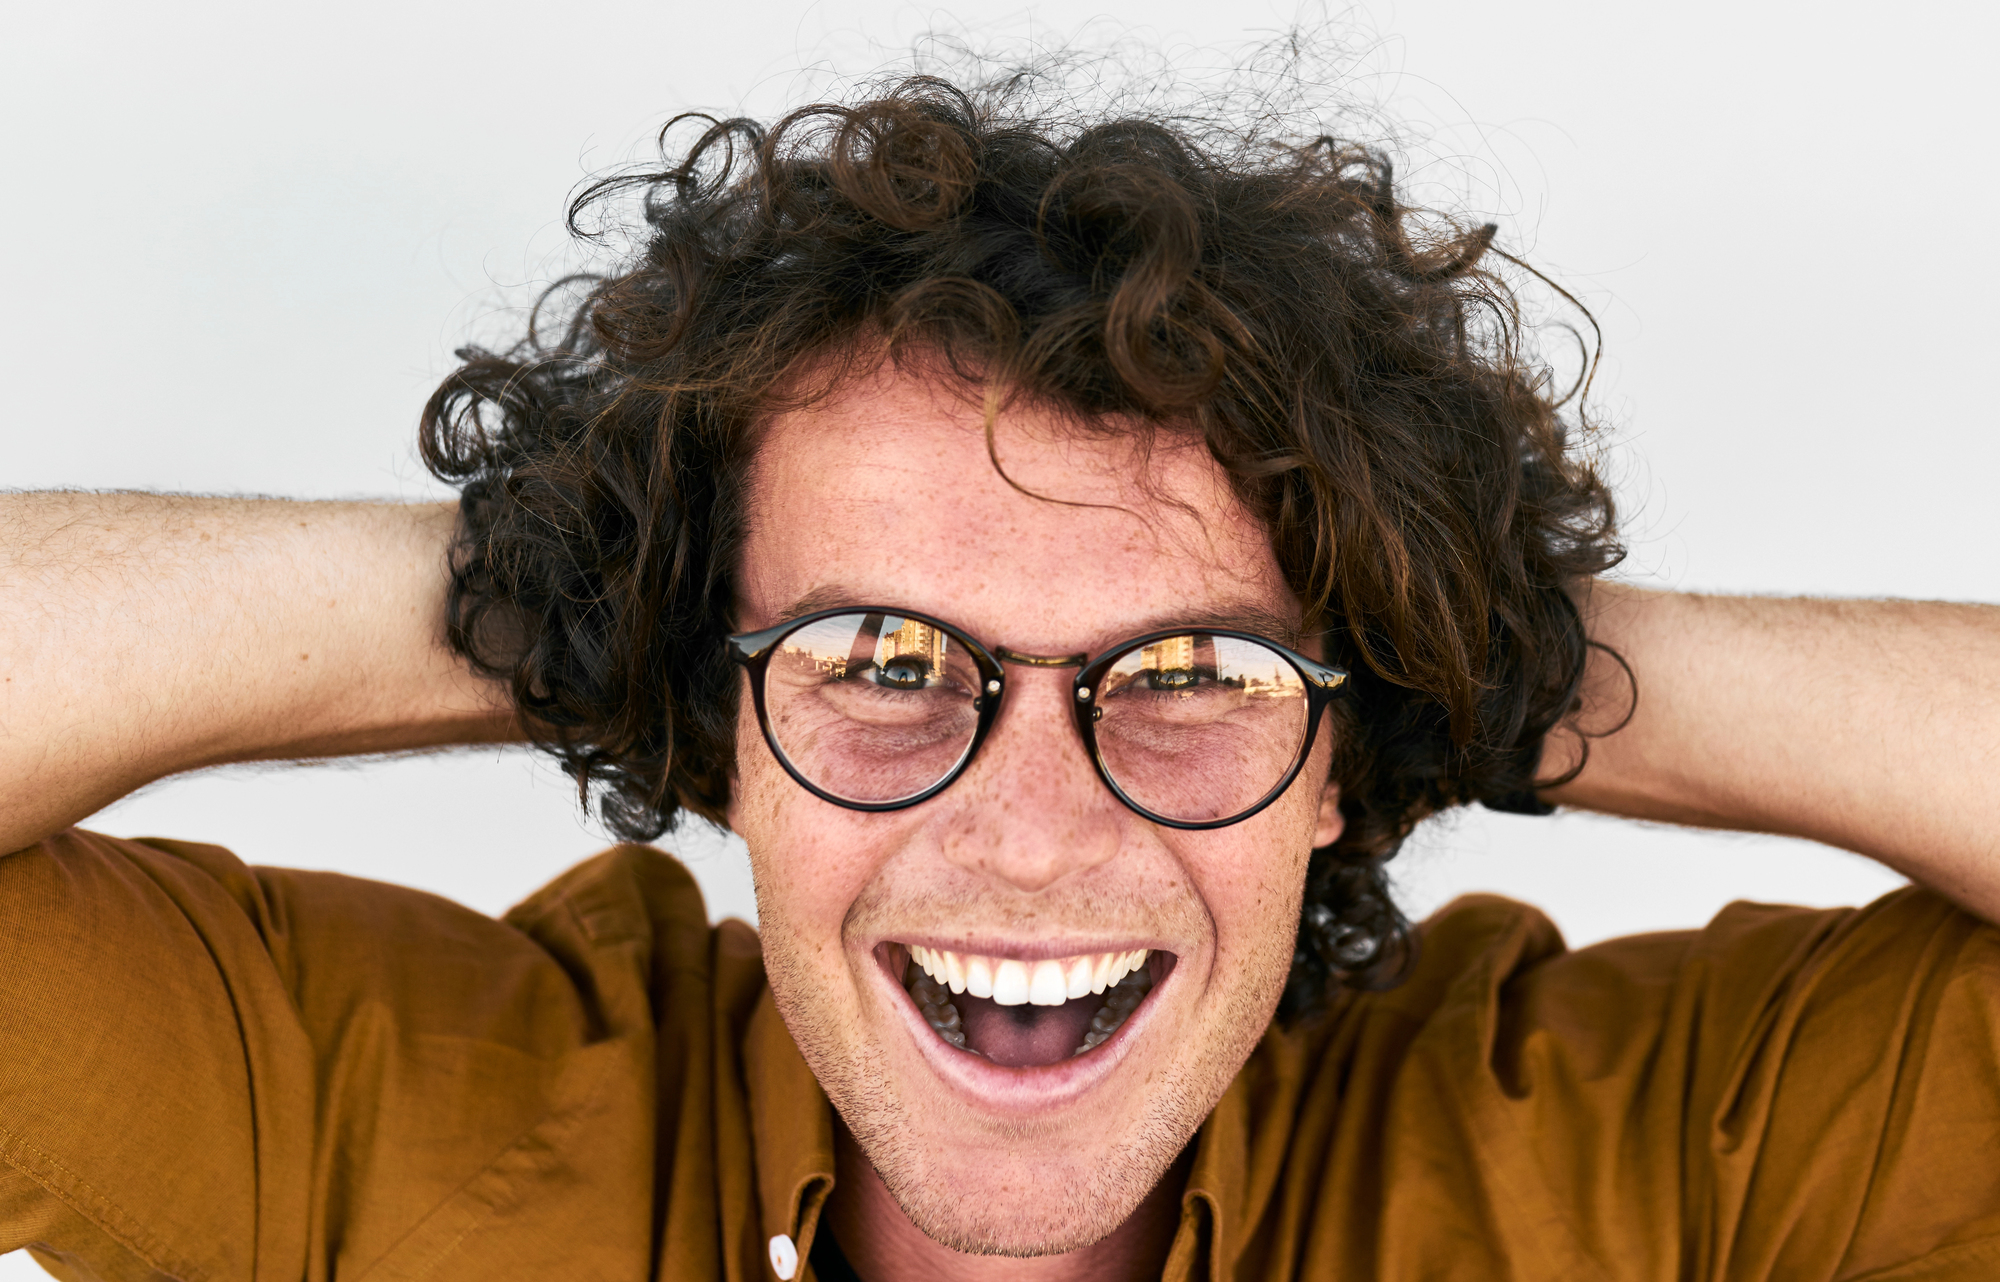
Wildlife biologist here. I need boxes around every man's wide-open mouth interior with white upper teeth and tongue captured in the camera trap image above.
[884,944,1174,1068]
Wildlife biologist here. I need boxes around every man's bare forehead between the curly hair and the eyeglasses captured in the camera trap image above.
[738,366,1298,652]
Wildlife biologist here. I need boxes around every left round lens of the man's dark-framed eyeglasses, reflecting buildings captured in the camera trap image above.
[764,612,980,802]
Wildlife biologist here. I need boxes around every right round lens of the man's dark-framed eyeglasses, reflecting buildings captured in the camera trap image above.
[1096,632,1310,824]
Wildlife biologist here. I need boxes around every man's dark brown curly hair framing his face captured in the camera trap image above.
[422,76,1622,1018]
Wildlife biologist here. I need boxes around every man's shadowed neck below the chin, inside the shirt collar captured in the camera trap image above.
[822,1118,1194,1282]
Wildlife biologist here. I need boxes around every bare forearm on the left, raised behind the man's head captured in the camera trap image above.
[0,494,516,852]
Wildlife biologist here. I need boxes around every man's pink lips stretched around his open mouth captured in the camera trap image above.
[868,938,1180,1116]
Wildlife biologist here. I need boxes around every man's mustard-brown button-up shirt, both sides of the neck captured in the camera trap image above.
[0,832,2000,1282]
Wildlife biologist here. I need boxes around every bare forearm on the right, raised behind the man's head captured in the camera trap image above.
[1542,584,2000,922]
